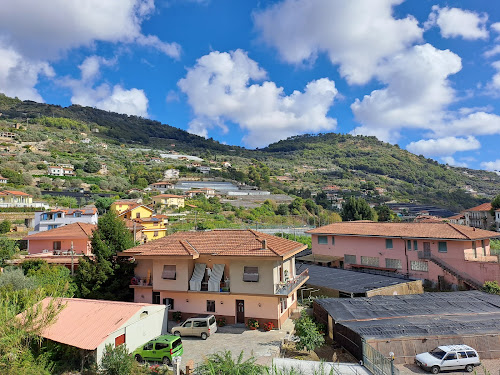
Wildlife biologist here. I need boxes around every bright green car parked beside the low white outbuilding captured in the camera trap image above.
[132,335,184,365]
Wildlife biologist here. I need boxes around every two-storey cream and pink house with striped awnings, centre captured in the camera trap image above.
[119,230,309,328]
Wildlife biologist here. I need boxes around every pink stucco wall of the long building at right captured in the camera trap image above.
[312,235,500,284]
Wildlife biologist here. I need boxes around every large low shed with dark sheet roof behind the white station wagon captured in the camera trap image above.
[313,291,500,364]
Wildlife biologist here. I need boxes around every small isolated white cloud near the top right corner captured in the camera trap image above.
[425,5,488,40]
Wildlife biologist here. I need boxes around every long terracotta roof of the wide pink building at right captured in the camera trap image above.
[307,221,500,241]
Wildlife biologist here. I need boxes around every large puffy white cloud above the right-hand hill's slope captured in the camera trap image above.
[351,44,462,141]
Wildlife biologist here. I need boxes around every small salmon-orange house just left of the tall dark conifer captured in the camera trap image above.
[23,223,96,255]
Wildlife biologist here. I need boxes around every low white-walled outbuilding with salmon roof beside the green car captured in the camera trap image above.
[34,297,168,363]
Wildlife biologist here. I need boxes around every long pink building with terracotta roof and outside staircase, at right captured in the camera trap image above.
[308,221,500,288]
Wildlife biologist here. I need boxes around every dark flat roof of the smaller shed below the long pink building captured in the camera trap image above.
[297,264,412,293]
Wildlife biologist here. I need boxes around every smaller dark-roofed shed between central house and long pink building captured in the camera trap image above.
[297,264,424,298]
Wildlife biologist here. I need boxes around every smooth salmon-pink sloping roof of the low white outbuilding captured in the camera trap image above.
[37,297,153,350]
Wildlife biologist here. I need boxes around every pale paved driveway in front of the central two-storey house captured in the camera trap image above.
[176,319,293,366]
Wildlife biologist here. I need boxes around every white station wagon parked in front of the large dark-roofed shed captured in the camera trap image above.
[415,345,481,374]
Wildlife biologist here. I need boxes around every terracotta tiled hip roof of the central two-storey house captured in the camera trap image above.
[124,230,306,257]
